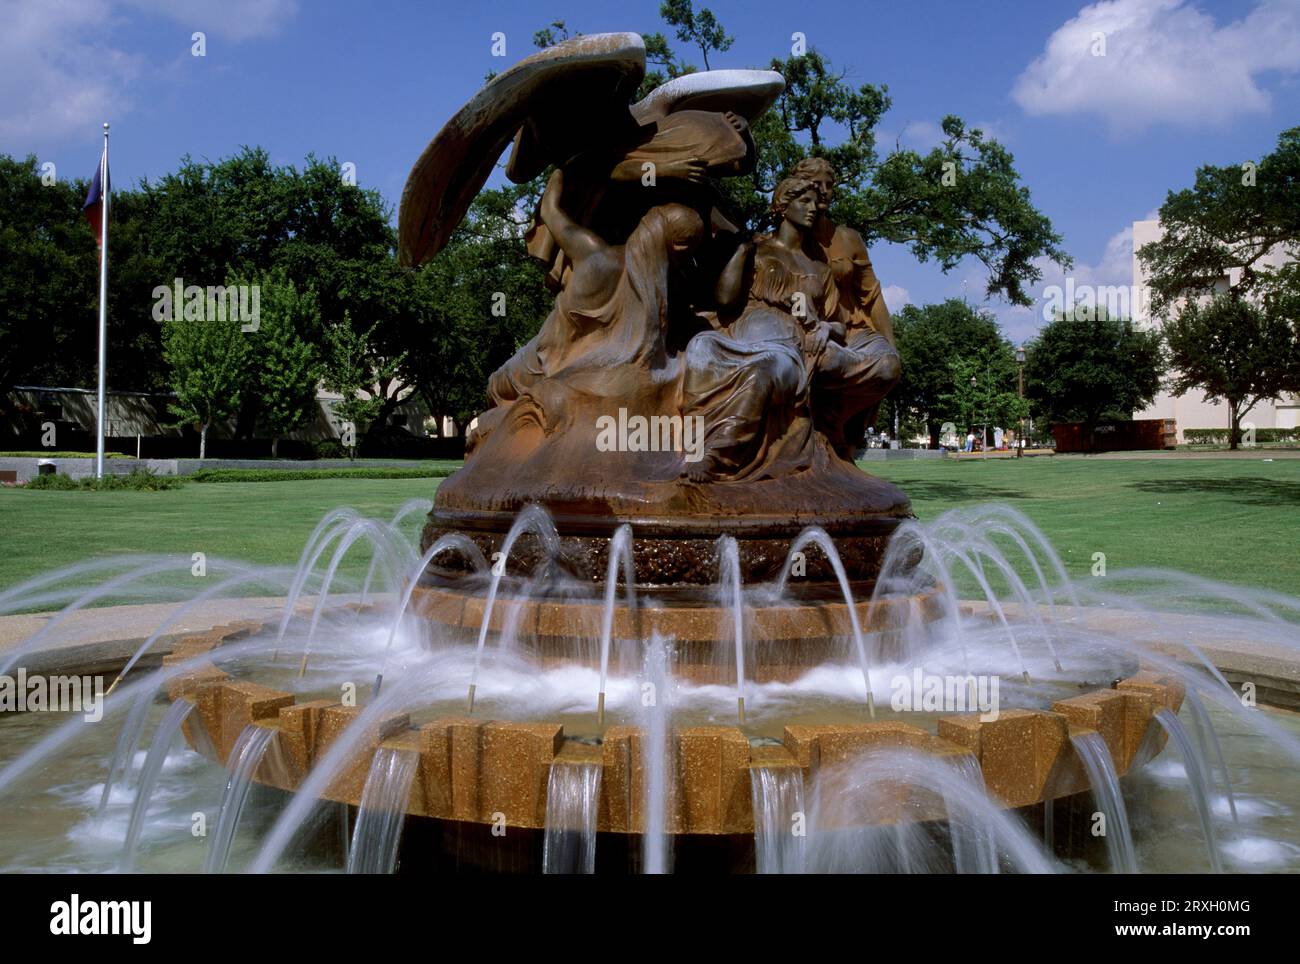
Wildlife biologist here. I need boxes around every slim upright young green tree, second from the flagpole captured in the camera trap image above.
[250,275,321,457]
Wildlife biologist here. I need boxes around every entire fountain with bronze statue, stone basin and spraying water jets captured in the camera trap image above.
[0,34,1300,873]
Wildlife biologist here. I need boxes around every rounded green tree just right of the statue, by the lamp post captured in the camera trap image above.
[885,298,1021,447]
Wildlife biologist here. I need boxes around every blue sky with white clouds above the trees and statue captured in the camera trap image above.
[0,0,1300,340]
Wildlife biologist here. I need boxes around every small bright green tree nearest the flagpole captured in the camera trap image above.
[163,294,250,459]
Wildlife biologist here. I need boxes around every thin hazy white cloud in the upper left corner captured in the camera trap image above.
[0,0,296,147]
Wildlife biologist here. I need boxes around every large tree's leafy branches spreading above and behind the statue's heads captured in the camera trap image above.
[641,0,1071,305]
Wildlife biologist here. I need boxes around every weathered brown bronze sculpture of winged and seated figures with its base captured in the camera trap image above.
[399,34,911,587]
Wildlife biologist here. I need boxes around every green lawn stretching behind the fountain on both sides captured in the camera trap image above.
[0,455,1300,594]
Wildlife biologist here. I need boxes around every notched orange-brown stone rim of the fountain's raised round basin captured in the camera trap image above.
[164,621,1184,835]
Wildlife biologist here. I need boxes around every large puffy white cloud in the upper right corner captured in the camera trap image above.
[1011,0,1300,133]
